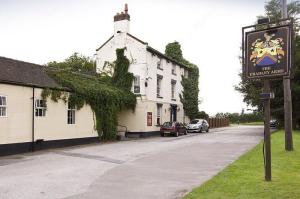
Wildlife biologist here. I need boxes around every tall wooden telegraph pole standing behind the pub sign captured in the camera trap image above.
[281,0,293,151]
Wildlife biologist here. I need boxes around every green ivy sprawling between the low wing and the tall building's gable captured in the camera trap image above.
[42,49,136,140]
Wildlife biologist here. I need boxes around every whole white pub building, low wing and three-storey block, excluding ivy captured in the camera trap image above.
[0,3,188,156]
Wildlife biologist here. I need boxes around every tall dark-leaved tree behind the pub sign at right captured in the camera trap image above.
[235,0,300,128]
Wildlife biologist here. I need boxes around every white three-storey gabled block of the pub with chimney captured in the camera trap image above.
[96,5,188,133]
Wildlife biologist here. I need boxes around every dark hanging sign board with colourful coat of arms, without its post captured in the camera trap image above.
[243,19,292,79]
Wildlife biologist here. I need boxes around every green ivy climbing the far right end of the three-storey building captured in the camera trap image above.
[165,41,199,119]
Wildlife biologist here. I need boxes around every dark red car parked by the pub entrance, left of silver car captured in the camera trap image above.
[160,122,187,137]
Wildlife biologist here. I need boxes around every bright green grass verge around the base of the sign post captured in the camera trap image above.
[184,131,300,199]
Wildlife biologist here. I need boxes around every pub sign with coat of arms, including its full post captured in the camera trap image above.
[242,19,293,181]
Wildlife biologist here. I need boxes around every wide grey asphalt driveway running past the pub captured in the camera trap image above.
[0,126,263,199]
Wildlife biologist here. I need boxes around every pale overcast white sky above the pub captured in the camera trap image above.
[0,0,274,115]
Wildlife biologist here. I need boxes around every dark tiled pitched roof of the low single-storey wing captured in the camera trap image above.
[0,57,59,88]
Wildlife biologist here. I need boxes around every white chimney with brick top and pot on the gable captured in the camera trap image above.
[114,3,130,35]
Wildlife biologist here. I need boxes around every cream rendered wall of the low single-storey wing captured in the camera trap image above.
[0,84,97,144]
